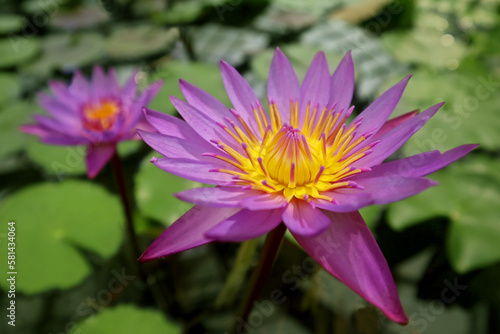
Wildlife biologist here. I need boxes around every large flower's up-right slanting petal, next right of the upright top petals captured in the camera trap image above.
[353,75,411,139]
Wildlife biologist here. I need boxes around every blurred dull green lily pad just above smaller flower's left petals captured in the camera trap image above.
[23,33,105,76]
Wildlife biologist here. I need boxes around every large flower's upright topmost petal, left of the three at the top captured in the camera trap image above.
[267,48,300,124]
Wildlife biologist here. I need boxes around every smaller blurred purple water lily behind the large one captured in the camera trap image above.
[21,66,162,178]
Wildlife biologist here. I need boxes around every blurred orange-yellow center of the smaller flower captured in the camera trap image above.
[83,99,120,131]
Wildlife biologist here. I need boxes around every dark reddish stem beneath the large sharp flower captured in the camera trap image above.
[240,223,286,322]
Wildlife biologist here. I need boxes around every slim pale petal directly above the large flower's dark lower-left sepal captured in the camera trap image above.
[174,187,261,208]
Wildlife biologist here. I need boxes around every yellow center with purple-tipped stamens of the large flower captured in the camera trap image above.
[206,101,377,201]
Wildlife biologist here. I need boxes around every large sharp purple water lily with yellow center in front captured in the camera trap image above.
[139,49,475,323]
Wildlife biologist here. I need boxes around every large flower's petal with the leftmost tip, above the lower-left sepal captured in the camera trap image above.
[137,130,216,162]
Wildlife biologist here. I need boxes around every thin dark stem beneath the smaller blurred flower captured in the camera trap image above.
[111,152,146,280]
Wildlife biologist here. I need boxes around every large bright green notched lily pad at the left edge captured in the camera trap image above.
[0,181,123,294]
